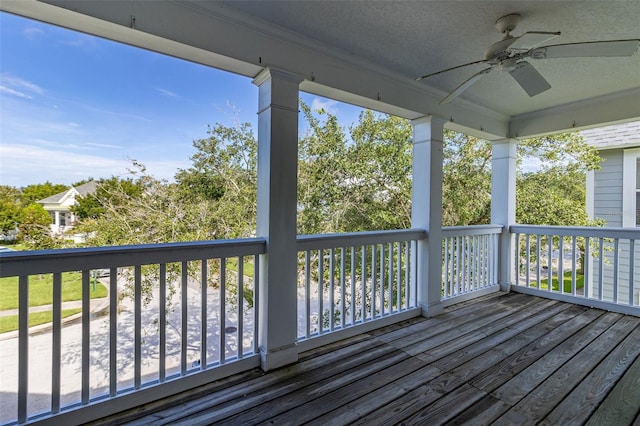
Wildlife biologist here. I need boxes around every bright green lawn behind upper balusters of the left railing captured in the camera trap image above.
[0,272,107,311]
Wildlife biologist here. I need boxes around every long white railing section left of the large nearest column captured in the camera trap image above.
[0,239,266,423]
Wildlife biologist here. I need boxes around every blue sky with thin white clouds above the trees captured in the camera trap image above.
[0,13,360,187]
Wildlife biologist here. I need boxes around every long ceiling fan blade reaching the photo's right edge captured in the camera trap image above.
[531,39,640,59]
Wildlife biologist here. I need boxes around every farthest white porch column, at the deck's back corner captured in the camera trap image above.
[491,139,518,291]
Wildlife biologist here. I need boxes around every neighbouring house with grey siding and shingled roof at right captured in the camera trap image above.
[582,121,640,303]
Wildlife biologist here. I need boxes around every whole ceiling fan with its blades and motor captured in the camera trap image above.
[416,13,640,104]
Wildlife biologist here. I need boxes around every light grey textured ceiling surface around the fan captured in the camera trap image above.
[216,1,640,115]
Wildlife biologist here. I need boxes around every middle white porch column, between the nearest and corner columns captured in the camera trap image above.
[411,116,445,317]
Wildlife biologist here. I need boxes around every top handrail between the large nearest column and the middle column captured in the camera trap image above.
[296,229,427,251]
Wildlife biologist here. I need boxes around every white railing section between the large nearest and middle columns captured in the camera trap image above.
[297,230,426,341]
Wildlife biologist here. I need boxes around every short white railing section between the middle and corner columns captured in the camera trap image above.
[442,225,502,302]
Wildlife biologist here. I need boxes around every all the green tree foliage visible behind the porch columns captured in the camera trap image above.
[74,103,599,244]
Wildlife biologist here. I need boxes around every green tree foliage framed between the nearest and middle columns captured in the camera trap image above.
[298,103,412,234]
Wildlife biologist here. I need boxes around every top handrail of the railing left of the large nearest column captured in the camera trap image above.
[0,238,266,278]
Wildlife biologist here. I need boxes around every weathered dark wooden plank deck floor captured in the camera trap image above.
[95,293,640,425]
